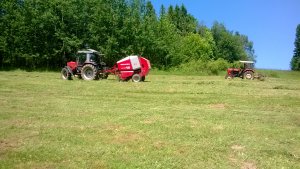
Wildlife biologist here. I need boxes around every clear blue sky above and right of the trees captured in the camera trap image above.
[151,0,300,70]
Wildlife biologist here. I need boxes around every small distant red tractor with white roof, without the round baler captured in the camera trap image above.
[225,61,255,80]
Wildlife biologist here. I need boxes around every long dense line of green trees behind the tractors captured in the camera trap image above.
[0,0,255,69]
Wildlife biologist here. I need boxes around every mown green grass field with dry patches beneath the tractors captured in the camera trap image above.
[0,71,300,169]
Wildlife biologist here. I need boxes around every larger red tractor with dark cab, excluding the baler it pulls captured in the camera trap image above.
[61,49,108,80]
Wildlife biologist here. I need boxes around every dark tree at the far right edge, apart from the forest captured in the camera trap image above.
[291,24,300,71]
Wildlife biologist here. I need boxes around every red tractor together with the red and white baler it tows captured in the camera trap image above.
[61,49,151,82]
